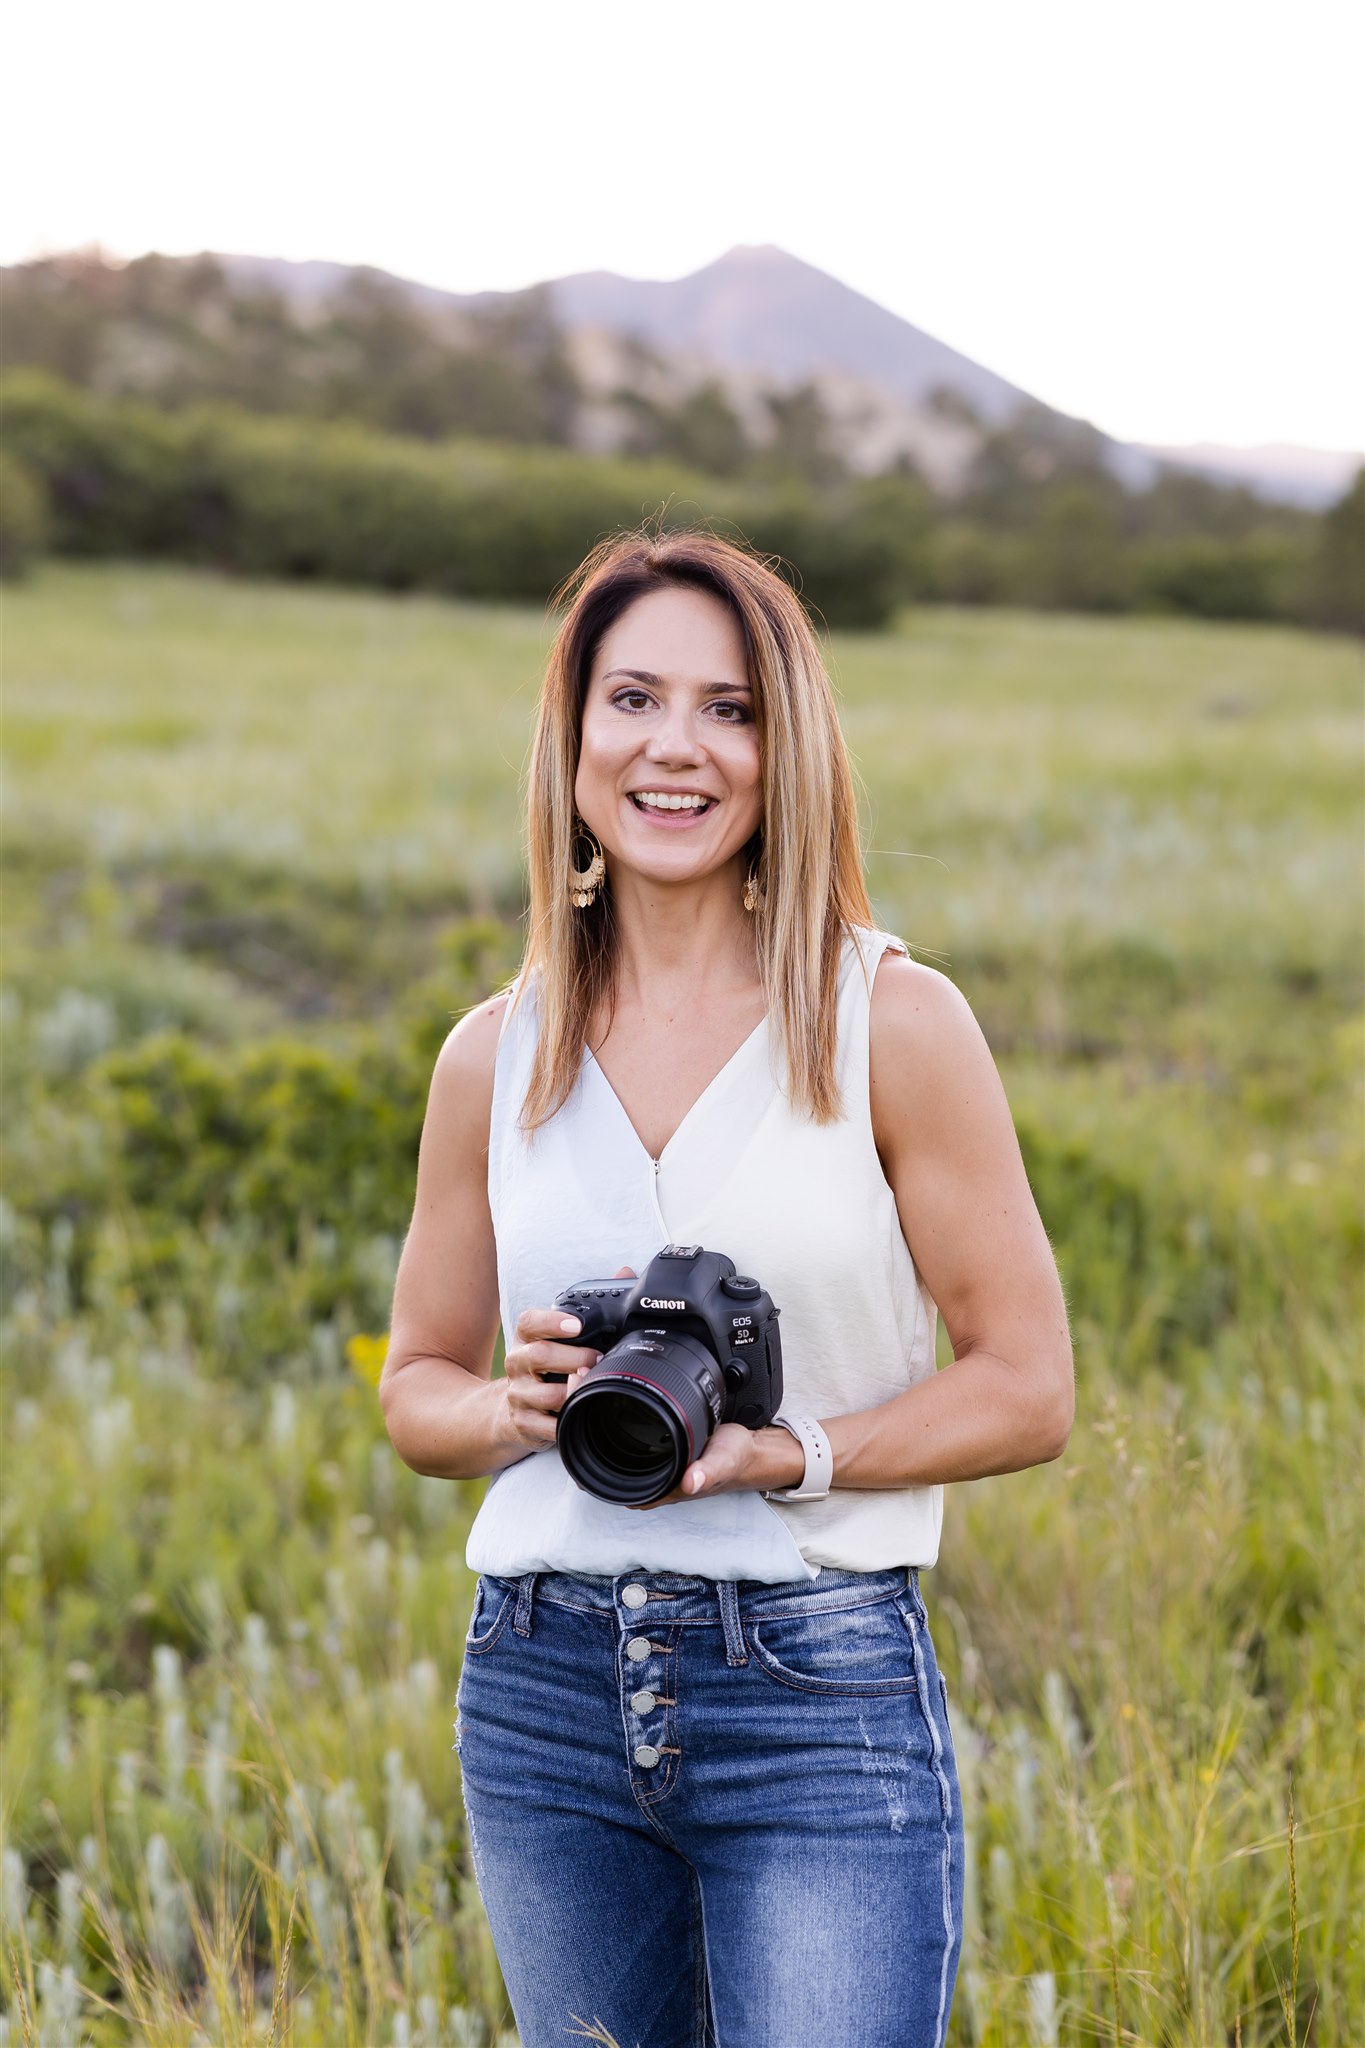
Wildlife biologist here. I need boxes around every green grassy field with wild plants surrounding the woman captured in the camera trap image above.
[0,565,1365,2048]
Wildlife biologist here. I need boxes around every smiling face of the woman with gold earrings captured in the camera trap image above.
[573,586,763,883]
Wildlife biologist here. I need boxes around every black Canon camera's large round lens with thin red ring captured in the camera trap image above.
[557,1331,714,1507]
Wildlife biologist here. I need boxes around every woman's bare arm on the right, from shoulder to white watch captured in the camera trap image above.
[825,954,1074,1487]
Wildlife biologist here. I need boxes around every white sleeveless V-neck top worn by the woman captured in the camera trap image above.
[467,932,943,1583]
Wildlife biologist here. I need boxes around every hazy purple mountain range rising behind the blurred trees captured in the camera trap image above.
[210,246,1361,508]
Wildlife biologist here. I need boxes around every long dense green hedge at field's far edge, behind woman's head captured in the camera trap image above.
[0,373,923,627]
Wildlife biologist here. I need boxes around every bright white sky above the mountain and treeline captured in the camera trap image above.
[0,0,1365,449]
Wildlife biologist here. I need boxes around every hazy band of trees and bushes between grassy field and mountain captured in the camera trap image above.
[0,254,1365,633]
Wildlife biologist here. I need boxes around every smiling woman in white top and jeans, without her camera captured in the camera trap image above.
[381,532,1072,2048]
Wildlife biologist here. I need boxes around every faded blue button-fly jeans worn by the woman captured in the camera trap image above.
[456,1569,962,2048]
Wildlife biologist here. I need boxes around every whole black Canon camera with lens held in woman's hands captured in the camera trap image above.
[546,1245,782,1507]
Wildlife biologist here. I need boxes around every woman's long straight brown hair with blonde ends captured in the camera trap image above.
[511,532,872,1130]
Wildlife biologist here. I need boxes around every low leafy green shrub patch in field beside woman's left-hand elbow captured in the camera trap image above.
[0,918,522,1351]
